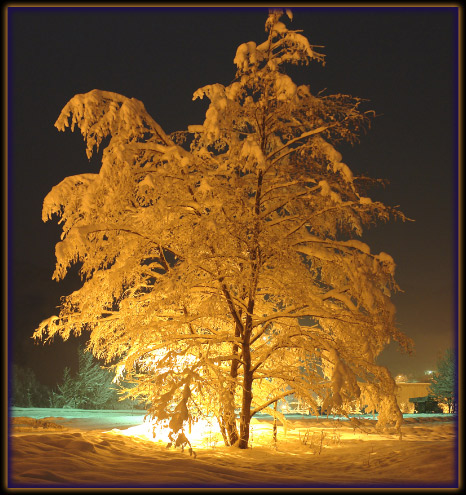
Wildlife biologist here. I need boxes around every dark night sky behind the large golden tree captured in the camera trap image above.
[7,6,458,385]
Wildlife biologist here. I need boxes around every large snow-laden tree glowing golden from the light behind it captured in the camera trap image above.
[35,10,410,448]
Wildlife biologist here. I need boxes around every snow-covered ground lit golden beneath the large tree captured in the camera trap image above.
[8,408,458,488]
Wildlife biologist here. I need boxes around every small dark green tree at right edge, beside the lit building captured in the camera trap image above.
[430,349,457,413]
